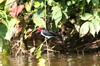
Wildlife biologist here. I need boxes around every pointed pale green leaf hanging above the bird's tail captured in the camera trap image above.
[52,6,62,27]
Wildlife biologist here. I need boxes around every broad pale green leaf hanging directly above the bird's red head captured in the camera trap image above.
[33,8,46,28]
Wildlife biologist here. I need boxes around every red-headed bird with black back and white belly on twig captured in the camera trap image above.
[38,28,62,40]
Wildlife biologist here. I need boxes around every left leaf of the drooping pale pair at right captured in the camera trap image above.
[80,22,90,37]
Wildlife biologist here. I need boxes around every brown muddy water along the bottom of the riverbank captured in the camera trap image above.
[0,54,100,66]
